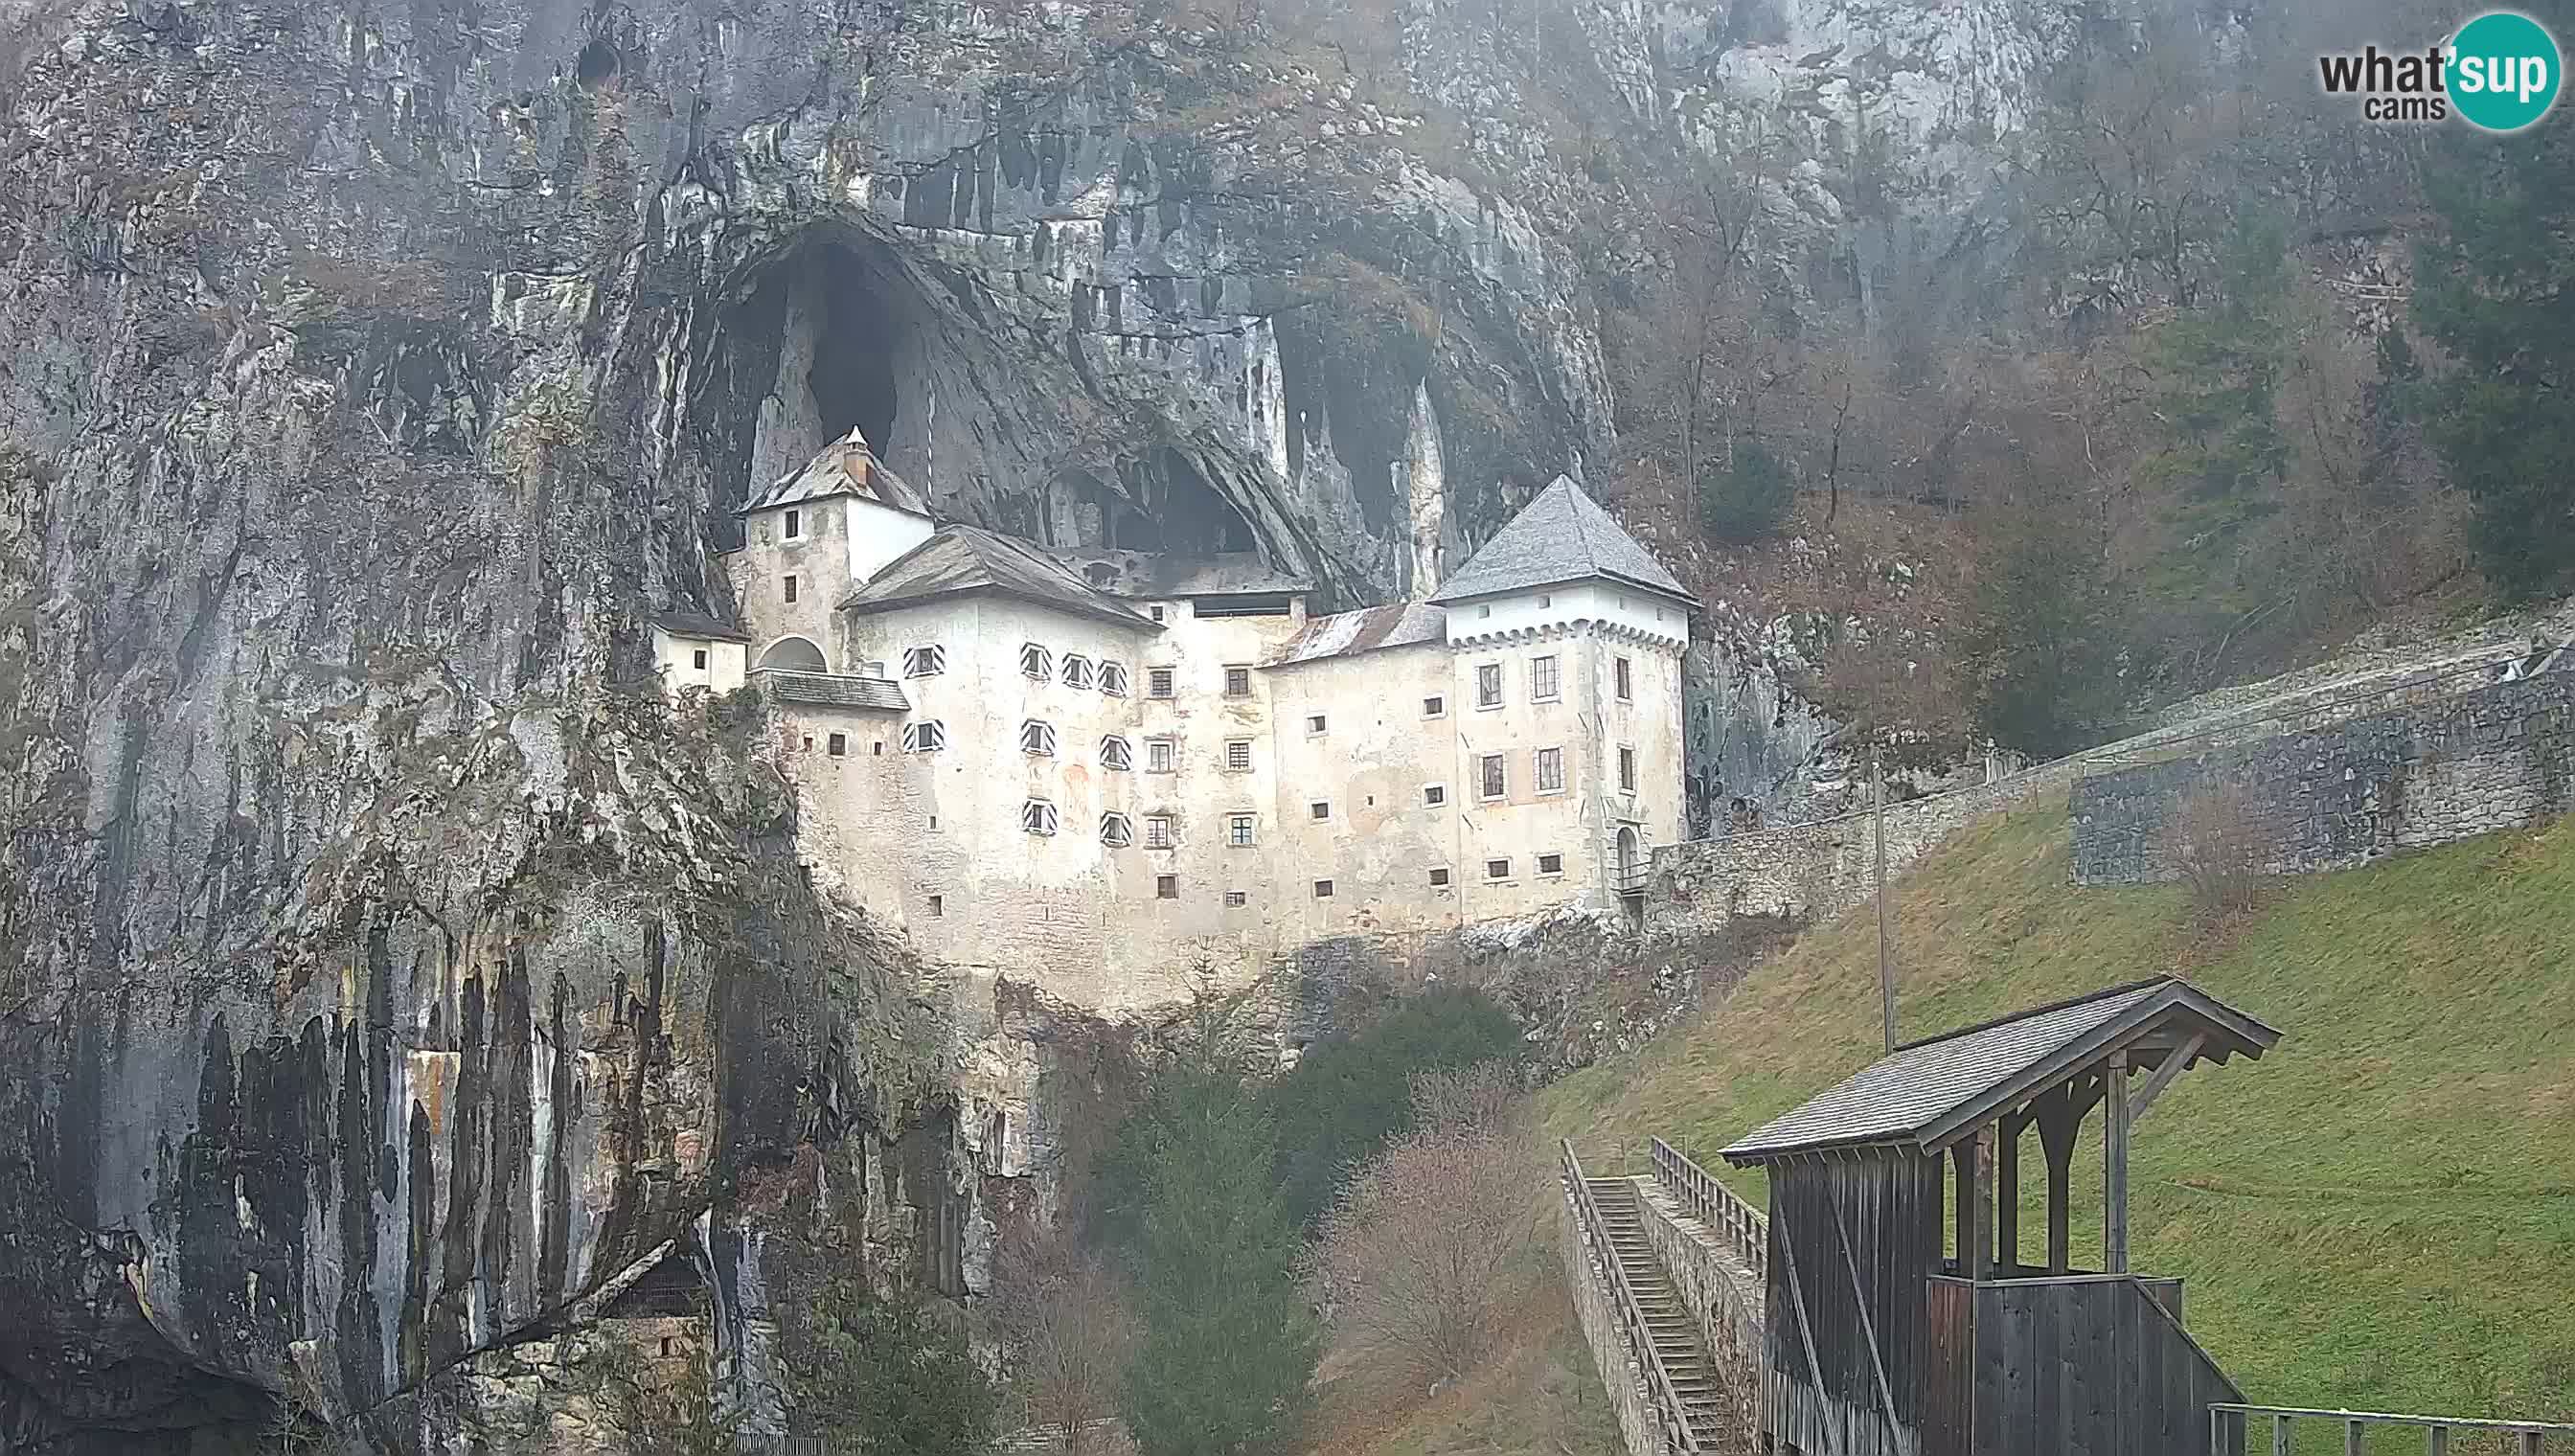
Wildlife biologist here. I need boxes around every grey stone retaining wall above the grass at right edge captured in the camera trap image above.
[2070,670,2575,884]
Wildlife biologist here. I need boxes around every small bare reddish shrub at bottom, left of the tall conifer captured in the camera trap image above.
[994,1235,1135,1456]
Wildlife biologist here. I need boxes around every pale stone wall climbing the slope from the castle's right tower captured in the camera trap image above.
[1646,761,2081,933]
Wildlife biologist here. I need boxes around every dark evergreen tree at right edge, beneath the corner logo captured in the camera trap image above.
[2413,59,2575,598]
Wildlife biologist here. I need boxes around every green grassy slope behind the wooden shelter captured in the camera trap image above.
[1542,802,2575,1422]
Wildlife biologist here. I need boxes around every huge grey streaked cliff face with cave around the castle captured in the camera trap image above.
[0,0,2111,1453]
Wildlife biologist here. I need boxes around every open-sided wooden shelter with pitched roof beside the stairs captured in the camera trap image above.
[1725,977,2279,1456]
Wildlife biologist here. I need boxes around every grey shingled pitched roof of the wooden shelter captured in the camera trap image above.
[1722,977,2279,1162]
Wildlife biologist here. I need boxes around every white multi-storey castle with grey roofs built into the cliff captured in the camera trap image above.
[654,430,1697,1012]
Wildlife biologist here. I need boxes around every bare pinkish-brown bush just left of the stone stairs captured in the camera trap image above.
[1313,1064,1535,1376]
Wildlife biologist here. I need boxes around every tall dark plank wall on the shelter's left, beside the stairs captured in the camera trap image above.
[1762,1154,1942,1456]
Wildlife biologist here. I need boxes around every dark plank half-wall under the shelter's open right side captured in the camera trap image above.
[1956,1278,2243,1456]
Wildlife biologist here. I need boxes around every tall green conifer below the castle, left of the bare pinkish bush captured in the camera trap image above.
[1120,1067,1321,1456]
